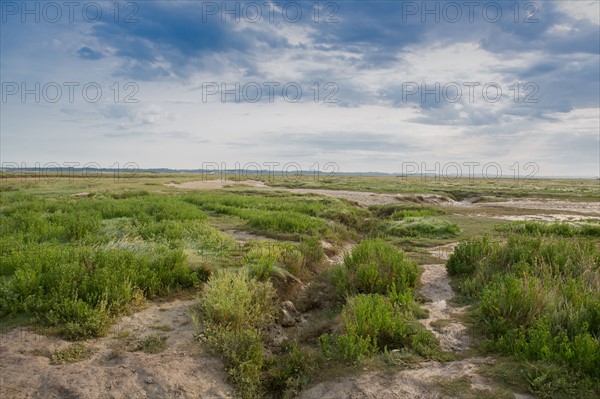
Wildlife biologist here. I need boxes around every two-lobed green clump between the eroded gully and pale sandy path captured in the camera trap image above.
[319,239,439,364]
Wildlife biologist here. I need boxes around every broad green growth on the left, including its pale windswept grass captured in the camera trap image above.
[0,192,239,339]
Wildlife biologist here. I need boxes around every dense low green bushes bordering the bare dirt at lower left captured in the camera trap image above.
[0,244,193,339]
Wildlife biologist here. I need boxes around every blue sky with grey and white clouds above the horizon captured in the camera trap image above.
[0,0,600,177]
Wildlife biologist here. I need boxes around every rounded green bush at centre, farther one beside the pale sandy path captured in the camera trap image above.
[337,239,418,294]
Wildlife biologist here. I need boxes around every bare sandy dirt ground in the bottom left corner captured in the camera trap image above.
[0,300,234,399]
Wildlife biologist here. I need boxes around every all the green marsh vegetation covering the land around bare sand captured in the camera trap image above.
[0,175,600,398]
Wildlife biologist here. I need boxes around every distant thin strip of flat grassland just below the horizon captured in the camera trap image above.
[0,172,600,201]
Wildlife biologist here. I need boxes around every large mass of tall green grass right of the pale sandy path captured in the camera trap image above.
[448,236,600,393]
